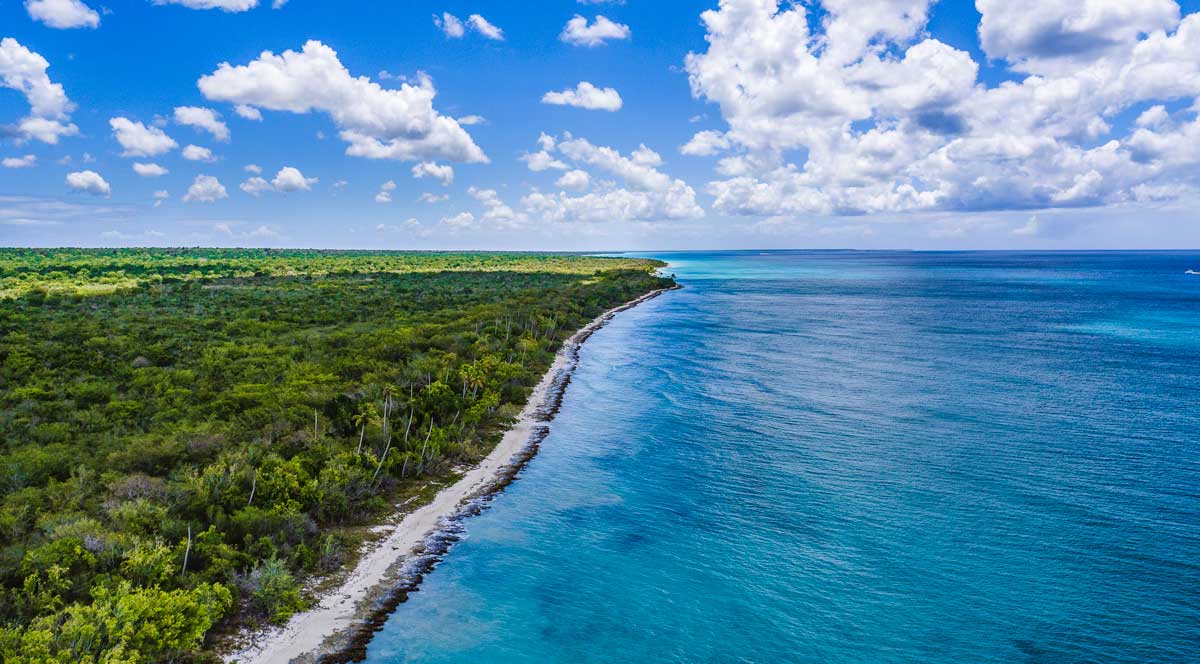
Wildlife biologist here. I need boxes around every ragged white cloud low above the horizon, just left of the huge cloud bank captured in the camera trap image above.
[521,134,704,222]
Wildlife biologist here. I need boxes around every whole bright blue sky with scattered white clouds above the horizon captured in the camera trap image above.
[0,0,1200,251]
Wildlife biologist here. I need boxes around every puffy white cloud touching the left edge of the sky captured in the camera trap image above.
[0,37,79,145]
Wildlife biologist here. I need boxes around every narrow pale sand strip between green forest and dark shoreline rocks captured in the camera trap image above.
[226,285,664,664]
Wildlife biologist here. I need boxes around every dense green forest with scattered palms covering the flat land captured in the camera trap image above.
[0,250,671,664]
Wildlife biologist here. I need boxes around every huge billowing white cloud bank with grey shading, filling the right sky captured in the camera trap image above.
[682,0,1200,216]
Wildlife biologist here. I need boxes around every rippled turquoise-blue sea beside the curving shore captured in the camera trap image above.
[368,252,1200,663]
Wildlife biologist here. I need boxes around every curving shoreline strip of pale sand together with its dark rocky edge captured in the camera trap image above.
[223,286,680,664]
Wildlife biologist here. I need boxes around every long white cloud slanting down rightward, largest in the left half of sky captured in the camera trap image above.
[198,41,487,163]
